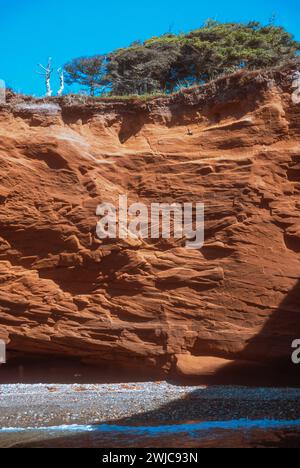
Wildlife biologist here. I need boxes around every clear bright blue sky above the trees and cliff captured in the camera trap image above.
[0,0,300,96]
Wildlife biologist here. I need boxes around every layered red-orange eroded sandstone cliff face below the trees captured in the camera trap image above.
[0,67,300,375]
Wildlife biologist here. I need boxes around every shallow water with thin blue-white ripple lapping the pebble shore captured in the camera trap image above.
[0,419,300,448]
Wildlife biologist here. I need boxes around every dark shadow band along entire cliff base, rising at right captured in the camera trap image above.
[0,281,300,387]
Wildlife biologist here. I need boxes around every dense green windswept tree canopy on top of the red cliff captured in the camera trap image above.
[65,20,300,95]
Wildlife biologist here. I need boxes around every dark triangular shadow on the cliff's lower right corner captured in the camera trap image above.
[175,281,300,387]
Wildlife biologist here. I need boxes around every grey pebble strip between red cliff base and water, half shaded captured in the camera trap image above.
[0,382,300,428]
